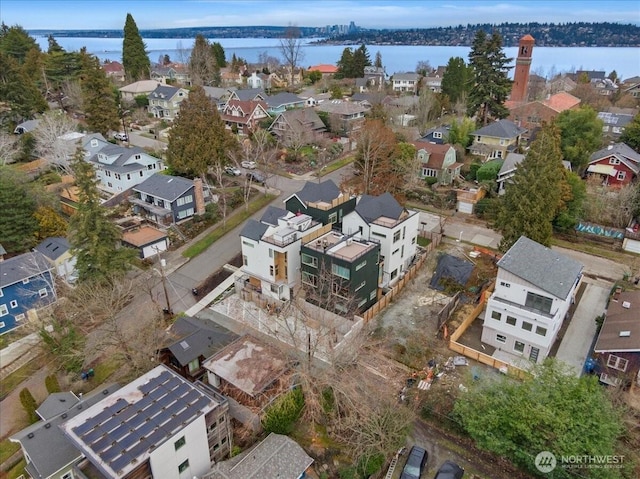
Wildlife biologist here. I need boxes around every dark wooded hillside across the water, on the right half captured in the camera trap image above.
[320,22,640,47]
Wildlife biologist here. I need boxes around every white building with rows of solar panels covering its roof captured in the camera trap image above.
[58,365,232,479]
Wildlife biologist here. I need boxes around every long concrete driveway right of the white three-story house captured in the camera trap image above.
[556,280,611,376]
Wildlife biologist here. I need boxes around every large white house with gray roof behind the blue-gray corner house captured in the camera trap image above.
[87,143,165,194]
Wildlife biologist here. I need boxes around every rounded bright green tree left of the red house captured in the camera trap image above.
[555,106,603,174]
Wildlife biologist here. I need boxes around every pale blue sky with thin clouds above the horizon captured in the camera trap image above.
[0,0,640,30]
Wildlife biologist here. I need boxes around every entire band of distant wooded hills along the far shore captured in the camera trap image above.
[31,22,640,47]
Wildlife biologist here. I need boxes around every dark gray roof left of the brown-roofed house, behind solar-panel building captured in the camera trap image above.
[168,316,239,366]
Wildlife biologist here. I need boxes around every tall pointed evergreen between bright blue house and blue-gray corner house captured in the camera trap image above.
[69,149,136,282]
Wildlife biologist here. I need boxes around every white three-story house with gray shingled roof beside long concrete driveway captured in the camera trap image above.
[482,236,583,363]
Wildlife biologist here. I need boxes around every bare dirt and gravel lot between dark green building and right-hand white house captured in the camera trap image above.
[377,242,530,479]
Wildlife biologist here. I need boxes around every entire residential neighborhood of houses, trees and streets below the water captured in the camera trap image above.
[0,10,640,479]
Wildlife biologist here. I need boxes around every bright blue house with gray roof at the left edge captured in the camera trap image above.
[0,252,56,334]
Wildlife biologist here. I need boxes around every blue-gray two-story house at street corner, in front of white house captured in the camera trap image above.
[129,173,204,226]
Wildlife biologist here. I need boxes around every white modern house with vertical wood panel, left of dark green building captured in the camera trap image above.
[240,206,331,301]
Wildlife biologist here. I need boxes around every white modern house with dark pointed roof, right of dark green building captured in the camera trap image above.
[342,193,420,287]
